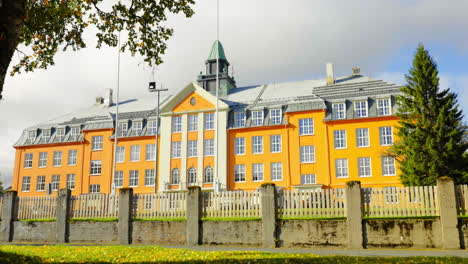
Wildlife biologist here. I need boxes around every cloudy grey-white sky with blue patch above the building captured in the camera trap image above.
[0,0,468,186]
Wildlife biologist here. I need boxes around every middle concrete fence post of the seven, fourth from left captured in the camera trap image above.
[185,186,202,246]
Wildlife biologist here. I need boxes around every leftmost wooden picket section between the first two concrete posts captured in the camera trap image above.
[16,196,57,220]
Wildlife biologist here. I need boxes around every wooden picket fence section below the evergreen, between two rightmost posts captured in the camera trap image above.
[362,186,439,217]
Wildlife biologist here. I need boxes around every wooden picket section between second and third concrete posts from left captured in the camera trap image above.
[70,194,119,218]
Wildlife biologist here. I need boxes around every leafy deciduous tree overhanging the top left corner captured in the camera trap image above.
[0,0,195,99]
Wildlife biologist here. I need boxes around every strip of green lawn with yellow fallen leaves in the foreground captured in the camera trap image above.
[0,246,466,264]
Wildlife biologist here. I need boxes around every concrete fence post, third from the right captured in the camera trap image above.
[261,183,278,248]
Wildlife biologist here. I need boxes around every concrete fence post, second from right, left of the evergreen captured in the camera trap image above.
[345,181,363,249]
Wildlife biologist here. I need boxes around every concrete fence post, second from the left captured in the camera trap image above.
[55,189,71,243]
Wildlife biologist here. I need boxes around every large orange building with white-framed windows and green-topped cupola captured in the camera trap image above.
[13,42,401,196]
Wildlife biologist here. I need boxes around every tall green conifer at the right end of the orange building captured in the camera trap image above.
[392,44,468,186]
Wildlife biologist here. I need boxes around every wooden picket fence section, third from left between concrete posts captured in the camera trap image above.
[132,192,187,219]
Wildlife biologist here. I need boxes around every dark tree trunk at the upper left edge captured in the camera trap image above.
[0,0,25,99]
